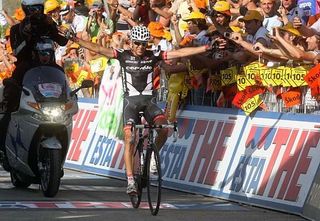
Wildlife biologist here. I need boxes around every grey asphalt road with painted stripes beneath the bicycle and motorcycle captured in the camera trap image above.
[0,167,306,221]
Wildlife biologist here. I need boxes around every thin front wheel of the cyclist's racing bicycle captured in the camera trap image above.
[146,144,162,216]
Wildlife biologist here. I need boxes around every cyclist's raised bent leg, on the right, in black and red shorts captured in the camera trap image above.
[145,97,168,150]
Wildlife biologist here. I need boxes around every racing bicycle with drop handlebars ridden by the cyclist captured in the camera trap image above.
[129,112,178,216]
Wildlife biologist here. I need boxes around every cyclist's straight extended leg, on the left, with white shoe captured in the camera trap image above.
[123,98,137,194]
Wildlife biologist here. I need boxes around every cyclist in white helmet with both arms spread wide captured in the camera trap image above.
[67,26,211,194]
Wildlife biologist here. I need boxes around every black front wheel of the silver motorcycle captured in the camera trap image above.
[39,148,62,197]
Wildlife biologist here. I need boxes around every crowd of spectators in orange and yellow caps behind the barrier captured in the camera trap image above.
[0,0,320,114]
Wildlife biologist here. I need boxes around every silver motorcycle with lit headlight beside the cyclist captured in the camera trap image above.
[0,40,93,197]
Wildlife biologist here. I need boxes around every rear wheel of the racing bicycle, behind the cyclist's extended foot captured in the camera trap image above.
[129,144,142,209]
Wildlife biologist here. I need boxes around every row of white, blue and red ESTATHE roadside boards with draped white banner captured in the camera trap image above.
[66,59,320,217]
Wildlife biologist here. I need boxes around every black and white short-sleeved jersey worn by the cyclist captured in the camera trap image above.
[114,49,167,96]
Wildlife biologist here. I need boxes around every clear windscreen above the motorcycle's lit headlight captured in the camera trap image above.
[22,66,70,102]
